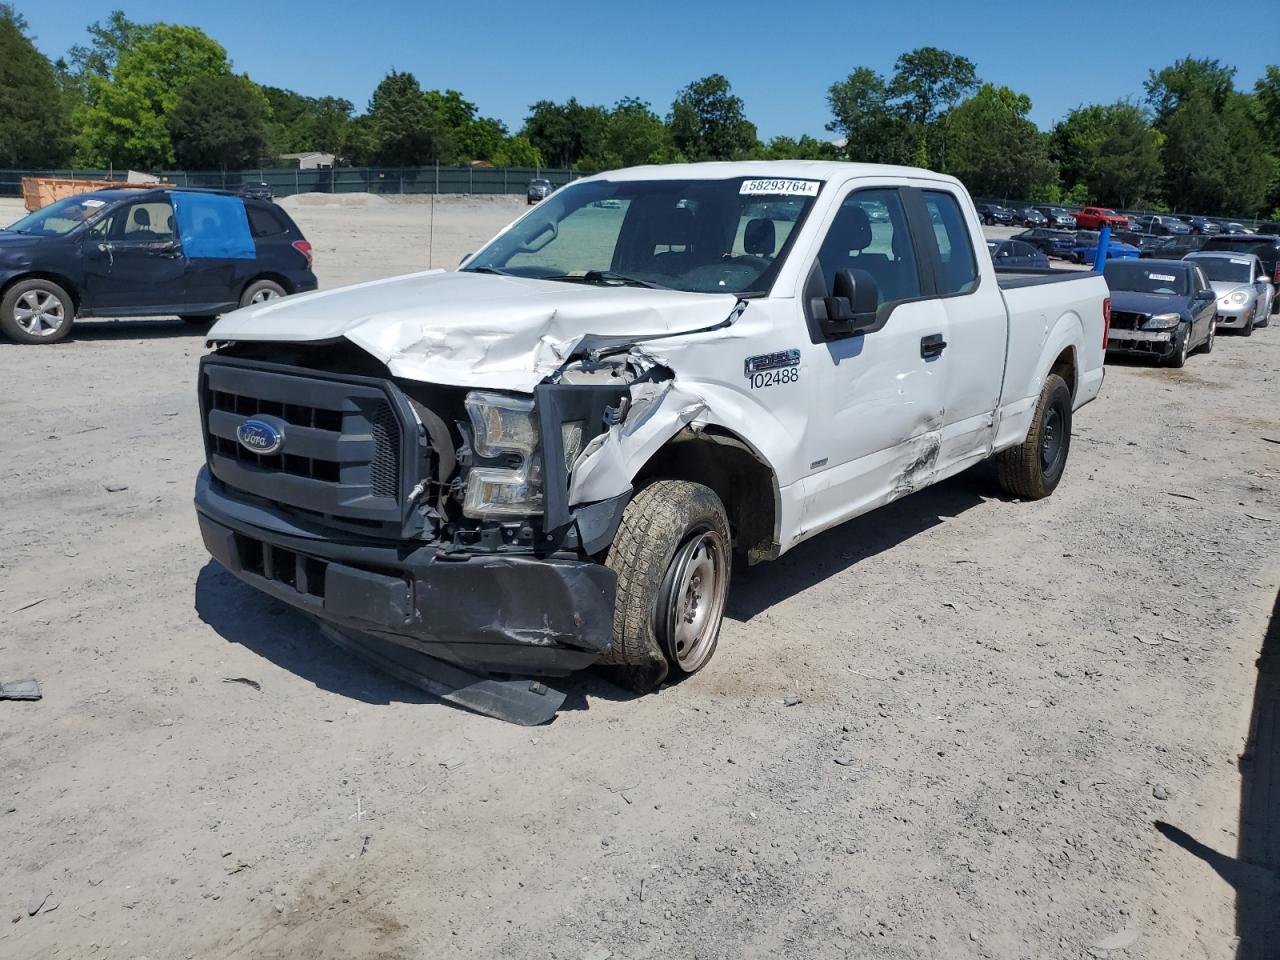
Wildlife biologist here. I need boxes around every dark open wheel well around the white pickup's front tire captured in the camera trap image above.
[634,428,778,563]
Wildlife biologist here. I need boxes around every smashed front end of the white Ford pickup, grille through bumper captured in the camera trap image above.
[196,340,703,723]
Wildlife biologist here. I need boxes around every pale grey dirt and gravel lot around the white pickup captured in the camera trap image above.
[0,195,1280,960]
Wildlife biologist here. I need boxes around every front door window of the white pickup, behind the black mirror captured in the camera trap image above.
[818,189,920,303]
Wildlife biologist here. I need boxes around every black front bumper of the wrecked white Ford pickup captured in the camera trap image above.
[196,467,617,692]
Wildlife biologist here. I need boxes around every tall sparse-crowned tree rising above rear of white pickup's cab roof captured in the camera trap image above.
[888,46,978,170]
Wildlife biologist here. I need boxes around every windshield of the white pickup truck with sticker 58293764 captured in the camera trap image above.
[463,177,819,293]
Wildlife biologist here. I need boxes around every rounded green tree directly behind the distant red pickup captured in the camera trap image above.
[1051,101,1164,207]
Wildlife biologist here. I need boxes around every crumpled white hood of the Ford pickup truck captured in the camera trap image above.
[209,270,737,392]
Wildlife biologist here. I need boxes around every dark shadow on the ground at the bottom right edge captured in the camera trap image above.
[1156,594,1280,960]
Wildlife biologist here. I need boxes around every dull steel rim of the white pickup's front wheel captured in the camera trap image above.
[659,529,728,673]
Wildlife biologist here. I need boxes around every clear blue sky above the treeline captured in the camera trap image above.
[14,0,1280,138]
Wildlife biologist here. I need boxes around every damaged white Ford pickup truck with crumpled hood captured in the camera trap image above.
[196,161,1110,723]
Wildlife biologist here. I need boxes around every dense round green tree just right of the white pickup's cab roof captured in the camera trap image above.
[950,83,1057,197]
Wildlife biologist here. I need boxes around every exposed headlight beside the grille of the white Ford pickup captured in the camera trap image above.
[462,392,543,520]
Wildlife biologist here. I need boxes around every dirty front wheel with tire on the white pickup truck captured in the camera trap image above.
[604,480,731,694]
